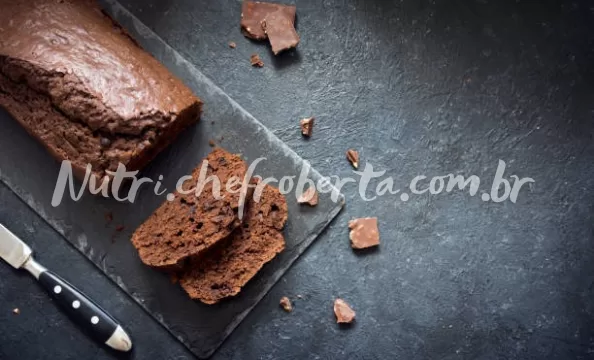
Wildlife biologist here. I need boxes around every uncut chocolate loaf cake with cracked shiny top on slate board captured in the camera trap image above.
[0,0,201,178]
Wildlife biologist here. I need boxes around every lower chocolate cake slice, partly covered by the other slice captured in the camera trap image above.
[179,185,288,304]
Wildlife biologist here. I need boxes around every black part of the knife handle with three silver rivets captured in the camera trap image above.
[39,271,118,344]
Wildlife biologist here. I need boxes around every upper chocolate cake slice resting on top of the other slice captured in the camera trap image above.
[132,148,247,270]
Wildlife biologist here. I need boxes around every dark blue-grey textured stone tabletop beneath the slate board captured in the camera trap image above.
[0,0,594,359]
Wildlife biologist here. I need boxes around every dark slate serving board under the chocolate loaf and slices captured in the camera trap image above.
[0,1,344,357]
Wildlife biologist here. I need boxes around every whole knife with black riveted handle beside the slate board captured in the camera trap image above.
[0,224,132,351]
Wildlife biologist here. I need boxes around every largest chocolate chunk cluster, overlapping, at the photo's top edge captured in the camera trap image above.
[241,1,299,55]
